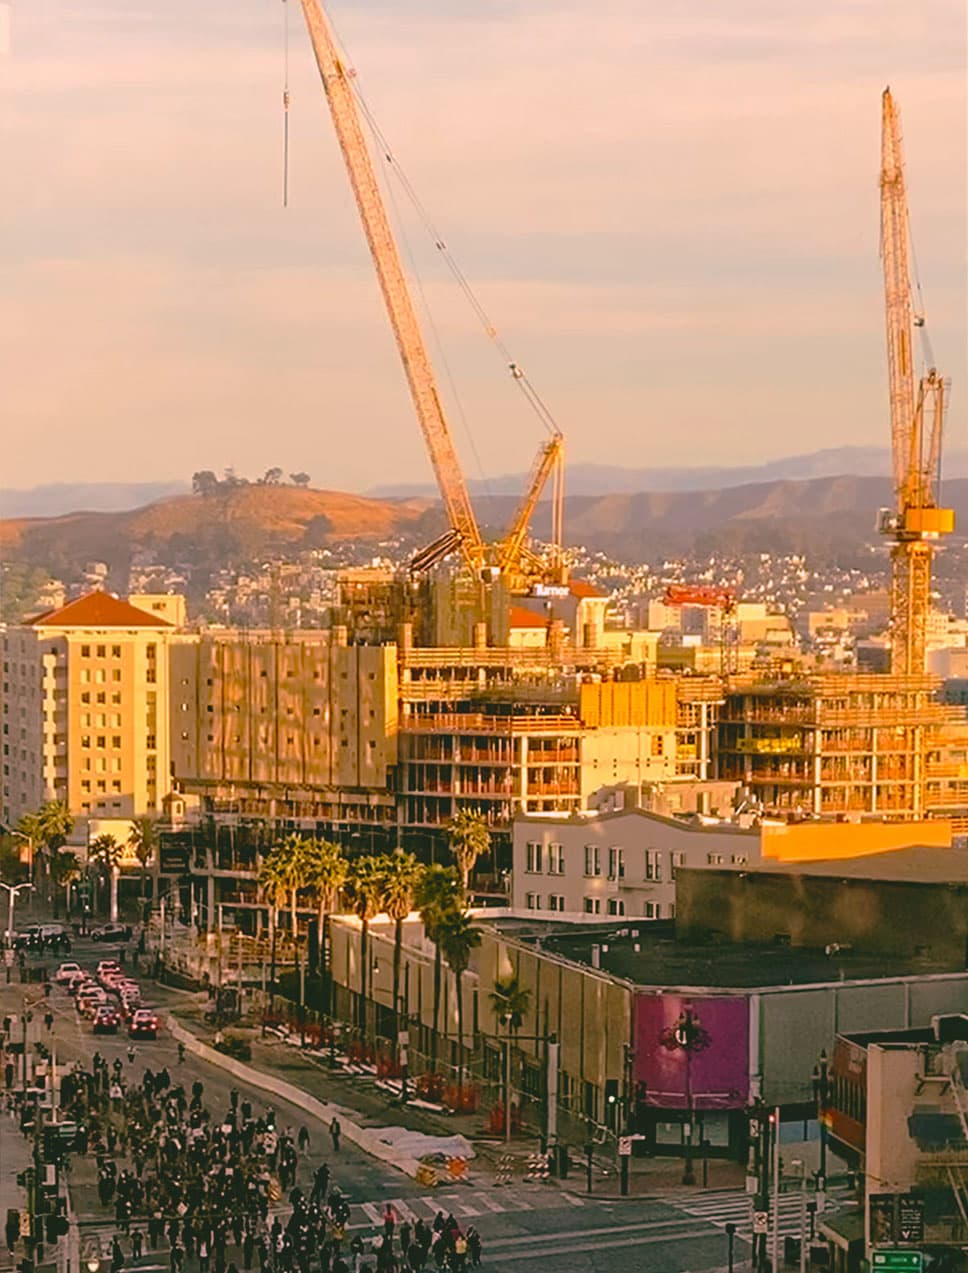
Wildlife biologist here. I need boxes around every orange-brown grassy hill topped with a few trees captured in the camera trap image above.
[0,485,439,587]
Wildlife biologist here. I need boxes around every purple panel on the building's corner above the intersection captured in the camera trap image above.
[634,994,749,1110]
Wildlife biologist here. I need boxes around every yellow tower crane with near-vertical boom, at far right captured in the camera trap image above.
[879,88,954,676]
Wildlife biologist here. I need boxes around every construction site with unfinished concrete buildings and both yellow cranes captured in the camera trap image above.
[160,9,968,875]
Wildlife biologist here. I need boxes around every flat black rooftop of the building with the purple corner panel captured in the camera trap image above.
[487,917,964,990]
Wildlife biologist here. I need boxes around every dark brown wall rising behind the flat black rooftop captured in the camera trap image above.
[676,869,968,969]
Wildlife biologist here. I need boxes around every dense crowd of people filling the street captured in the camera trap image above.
[55,1053,481,1273]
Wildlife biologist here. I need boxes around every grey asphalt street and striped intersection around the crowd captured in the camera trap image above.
[0,941,769,1273]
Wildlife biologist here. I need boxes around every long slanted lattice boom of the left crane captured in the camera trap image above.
[295,0,485,570]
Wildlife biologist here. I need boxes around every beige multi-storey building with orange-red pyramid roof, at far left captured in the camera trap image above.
[1,592,177,822]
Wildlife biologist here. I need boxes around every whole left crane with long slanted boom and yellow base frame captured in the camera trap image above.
[301,0,563,589]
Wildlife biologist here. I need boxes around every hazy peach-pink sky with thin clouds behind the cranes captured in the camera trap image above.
[0,0,968,489]
